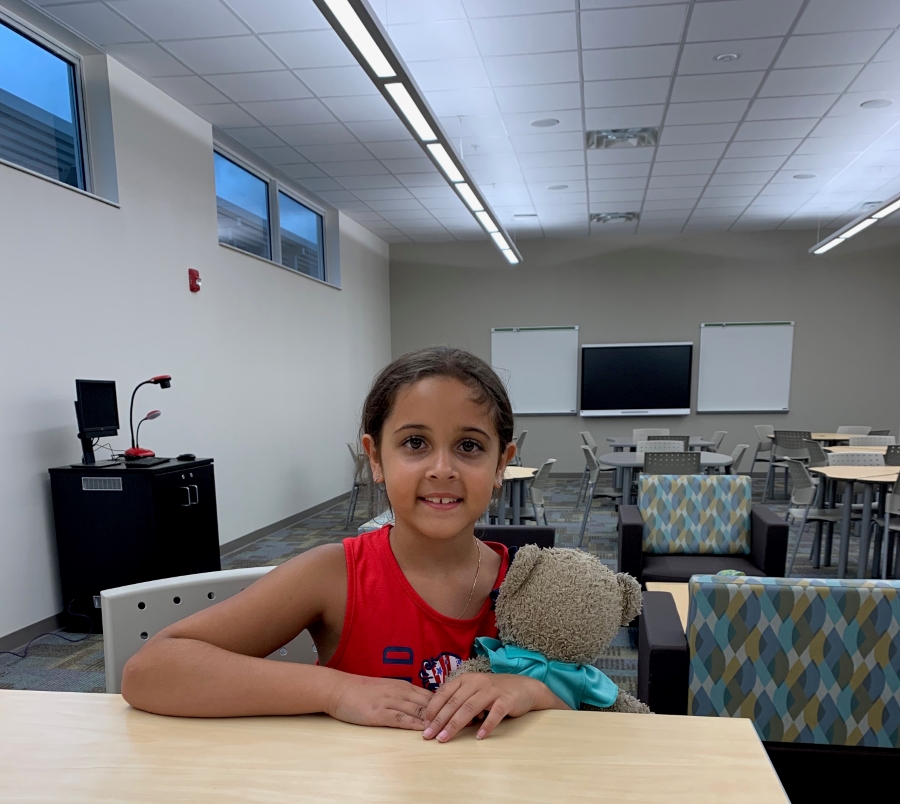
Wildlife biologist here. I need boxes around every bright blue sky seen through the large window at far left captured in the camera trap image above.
[0,23,73,123]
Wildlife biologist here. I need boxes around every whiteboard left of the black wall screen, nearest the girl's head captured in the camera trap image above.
[491,327,578,415]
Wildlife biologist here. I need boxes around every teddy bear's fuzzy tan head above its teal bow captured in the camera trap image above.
[496,544,641,664]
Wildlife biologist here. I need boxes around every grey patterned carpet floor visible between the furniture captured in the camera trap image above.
[0,478,859,694]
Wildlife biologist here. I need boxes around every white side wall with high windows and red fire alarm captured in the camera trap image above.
[0,60,390,636]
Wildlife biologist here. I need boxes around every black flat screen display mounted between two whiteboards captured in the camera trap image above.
[581,343,693,416]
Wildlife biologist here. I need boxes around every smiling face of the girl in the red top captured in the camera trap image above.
[363,377,516,539]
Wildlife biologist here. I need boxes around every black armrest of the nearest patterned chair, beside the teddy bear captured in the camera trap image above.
[637,592,688,715]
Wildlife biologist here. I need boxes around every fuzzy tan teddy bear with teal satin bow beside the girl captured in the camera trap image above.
[450,544,650,714]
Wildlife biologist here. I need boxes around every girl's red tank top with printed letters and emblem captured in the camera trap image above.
[326,526,509,690]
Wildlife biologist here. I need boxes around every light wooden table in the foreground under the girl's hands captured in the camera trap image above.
[0,690,787,804]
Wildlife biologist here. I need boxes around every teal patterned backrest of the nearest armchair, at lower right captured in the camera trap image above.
[687,575,900,748]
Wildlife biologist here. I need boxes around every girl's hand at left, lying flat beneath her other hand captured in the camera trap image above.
[327,674,434,731]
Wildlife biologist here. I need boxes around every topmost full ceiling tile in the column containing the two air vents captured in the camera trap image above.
[581,4,687,50]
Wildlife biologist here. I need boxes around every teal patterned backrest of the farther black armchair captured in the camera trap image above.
[638,475,752,555]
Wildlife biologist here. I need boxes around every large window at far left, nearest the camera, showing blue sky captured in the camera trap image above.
[0,22,87,190]
